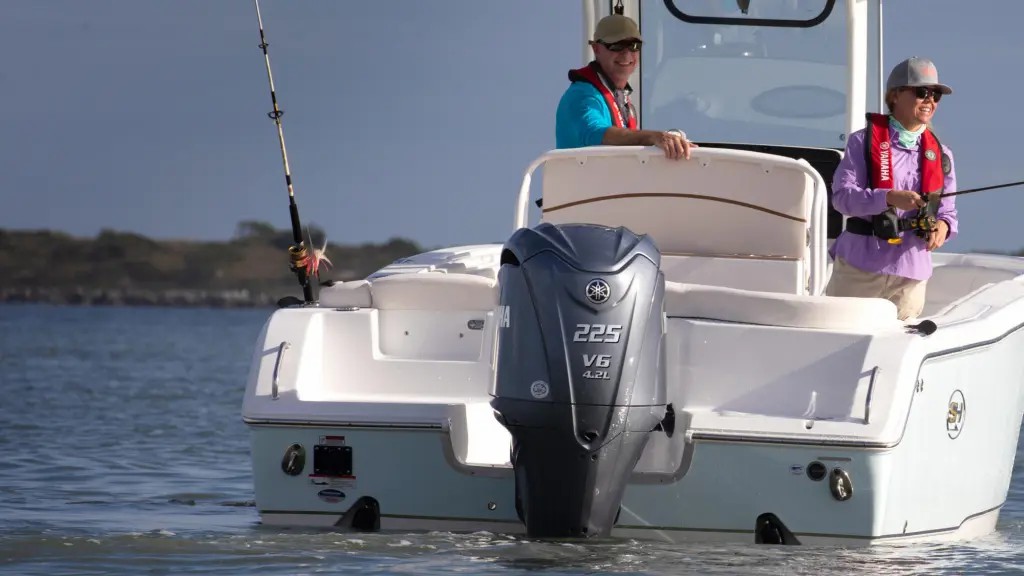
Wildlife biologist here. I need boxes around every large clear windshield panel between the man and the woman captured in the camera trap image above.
[640,0,849,149]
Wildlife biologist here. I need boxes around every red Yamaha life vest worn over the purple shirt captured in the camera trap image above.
[864,113,945,195]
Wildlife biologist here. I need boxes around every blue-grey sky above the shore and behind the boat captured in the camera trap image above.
[0,0,1024,252]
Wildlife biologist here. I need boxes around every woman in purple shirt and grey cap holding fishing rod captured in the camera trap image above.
[825,57,957,320]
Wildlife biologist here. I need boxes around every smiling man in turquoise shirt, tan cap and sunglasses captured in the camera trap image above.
[555,14,697,159]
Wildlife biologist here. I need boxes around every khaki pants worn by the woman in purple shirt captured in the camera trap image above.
[825,258,928,320]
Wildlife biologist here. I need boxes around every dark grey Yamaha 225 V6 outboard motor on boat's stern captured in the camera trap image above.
[490,223,666,537]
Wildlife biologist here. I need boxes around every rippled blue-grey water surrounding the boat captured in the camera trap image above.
[0,304,1024,575]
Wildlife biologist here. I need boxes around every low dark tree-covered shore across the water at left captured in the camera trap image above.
[0,220,424,306]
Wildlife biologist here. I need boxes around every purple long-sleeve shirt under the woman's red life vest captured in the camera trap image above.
[828,125,957,280]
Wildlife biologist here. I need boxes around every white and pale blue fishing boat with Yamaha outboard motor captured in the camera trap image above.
[243,0,1024,545]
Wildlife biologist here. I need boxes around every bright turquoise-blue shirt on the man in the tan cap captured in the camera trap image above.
[555,82,612,148]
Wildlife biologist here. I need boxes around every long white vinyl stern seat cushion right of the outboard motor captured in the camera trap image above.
[665,282,902,331]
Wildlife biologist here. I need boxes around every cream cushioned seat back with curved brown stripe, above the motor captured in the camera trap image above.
[542,147,824,293]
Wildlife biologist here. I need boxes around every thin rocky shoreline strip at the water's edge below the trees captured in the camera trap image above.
[0,288,289,308]
